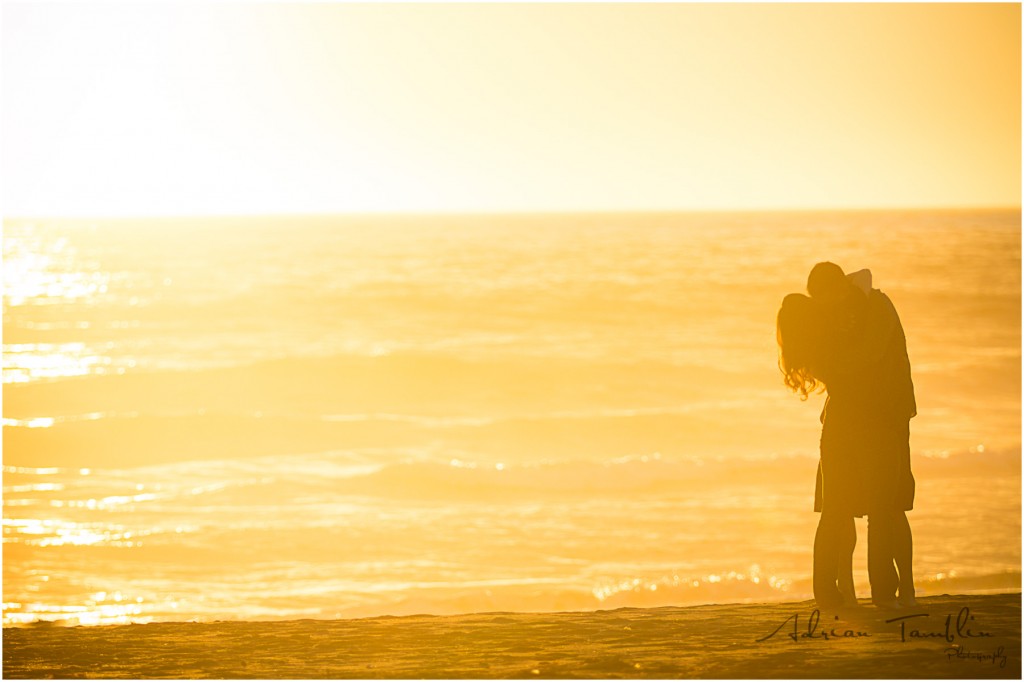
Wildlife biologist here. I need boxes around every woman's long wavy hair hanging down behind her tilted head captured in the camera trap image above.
[775,294,825,400]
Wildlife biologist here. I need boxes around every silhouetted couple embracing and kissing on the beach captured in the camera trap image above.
[776,262,918,608]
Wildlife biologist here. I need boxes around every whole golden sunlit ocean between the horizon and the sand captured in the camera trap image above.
[3,210,1021,625]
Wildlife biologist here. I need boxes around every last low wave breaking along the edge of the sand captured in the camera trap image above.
[3,565,1021,627]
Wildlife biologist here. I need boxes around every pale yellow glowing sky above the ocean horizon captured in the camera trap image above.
[0,2,1021,216]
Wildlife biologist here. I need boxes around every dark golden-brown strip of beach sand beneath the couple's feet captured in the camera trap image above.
[3,593,1021,679]
